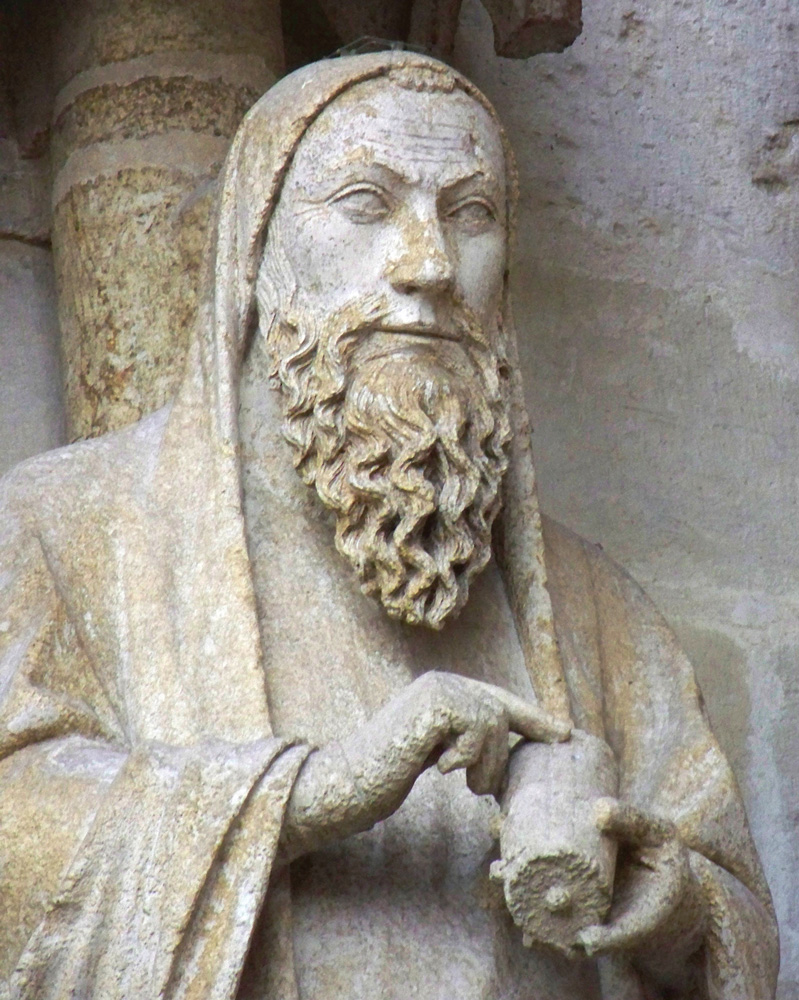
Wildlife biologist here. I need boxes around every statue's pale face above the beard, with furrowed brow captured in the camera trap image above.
[268,73,506,336]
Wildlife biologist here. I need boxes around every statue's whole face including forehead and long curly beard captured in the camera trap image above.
[258,79,510,627]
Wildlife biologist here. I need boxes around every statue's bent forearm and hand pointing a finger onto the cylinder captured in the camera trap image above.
[281,672,571,858]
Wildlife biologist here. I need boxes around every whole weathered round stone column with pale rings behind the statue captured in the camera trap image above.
[52,0,283,440]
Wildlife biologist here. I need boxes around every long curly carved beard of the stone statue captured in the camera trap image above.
[259,258,511,629]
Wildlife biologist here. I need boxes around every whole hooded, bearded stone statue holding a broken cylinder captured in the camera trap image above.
[0,52,777,1000]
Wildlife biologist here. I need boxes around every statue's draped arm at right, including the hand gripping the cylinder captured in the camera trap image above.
[546,522,779,1000]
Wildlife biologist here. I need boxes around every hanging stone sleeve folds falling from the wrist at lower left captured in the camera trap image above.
[11,740,306,1000]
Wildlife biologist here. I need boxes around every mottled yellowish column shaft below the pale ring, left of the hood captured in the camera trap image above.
[53,167,216,440]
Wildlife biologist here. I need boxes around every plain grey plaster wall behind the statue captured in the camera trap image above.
[0,0,799,1000]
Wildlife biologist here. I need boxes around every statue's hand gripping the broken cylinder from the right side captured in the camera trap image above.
[578,799,706,964]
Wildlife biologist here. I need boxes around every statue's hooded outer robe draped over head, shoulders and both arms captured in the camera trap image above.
[0,54,776,1000]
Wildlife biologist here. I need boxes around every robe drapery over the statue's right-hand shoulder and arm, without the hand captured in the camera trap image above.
[544,519,779,1000]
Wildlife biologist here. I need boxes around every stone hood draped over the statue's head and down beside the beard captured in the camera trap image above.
[167,51,568,715]
